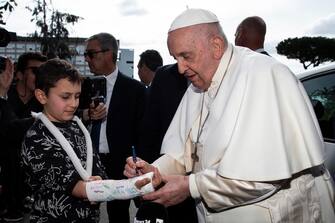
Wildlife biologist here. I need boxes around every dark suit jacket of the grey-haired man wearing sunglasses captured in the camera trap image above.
[102,72,145,179]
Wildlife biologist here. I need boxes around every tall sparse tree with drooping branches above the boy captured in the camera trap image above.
[26,0,82,59]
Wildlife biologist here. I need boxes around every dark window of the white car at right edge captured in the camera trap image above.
[302,71,335,142]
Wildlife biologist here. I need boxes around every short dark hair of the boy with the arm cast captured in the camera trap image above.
[35,58,82,95]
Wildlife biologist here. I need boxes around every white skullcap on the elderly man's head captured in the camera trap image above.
[169,9,219,32]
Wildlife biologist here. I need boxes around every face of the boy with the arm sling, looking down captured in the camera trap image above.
[37,79,81,122]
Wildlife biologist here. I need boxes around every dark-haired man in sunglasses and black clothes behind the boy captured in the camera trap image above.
[2,52,47,222]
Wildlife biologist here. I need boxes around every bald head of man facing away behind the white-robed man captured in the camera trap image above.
[235,16,269,56]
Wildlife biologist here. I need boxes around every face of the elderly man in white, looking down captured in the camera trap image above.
[168,25,216,90]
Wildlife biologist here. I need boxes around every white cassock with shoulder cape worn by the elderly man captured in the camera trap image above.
[154,44,335,223]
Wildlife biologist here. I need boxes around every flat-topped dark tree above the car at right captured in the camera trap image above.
[276,37,335,69]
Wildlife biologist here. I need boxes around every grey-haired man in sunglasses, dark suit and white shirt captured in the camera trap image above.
[83,33,145,222]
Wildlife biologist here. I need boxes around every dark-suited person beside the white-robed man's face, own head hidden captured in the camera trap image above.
[138,64,198,223]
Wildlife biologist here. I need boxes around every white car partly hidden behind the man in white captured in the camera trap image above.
[297,63,335,179]
